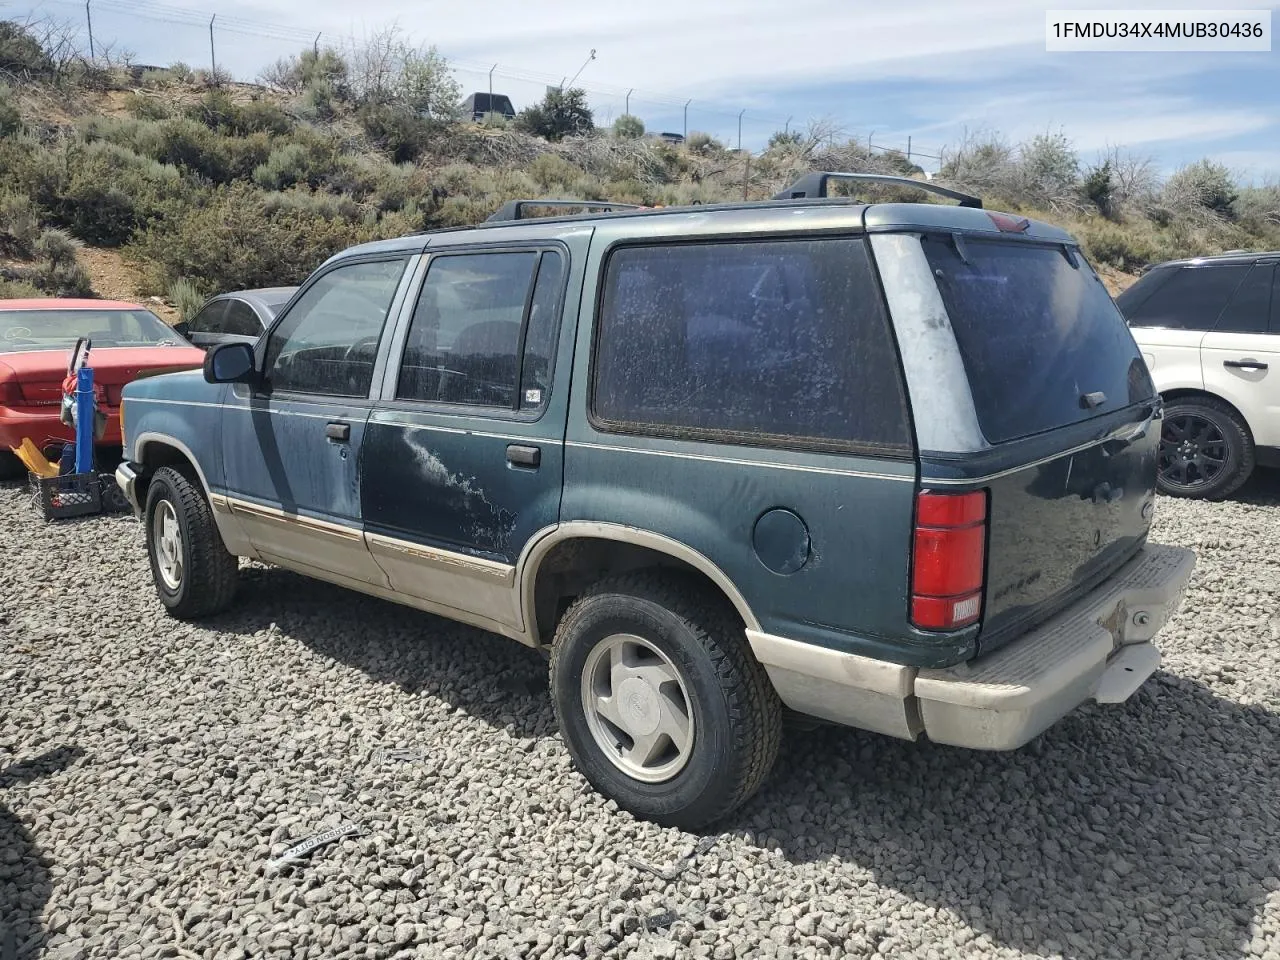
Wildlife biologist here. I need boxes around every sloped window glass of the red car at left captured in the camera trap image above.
[0,310,186,353]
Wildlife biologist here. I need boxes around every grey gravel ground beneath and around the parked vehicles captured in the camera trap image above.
[0,476,1280,959]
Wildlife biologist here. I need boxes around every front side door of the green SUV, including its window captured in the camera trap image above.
[223,256,407,586]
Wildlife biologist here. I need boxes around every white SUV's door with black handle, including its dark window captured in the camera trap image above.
[1201,260,1280,447]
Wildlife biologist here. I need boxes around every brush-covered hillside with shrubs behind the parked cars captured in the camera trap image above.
[0,22,1280,311]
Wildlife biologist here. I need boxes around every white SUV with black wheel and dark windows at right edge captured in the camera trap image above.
[1116,252,1280,499]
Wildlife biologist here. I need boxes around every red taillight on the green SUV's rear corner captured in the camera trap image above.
[911,490,987,630]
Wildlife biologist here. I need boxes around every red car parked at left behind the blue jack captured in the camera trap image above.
[0,298,205,479]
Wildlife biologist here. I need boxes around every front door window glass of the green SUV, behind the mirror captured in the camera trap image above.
[258,259,406,397]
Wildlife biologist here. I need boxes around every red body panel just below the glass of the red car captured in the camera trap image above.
[0,347,205,403]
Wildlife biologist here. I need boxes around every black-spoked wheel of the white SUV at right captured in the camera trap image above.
[1156,397,1256,500]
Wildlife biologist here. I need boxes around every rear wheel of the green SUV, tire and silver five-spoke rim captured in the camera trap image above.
[550,571,782,829]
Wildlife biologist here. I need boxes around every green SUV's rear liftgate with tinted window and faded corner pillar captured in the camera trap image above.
[876,233,1158,652]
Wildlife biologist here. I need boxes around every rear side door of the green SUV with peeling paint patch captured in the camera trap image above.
[361,244,585,632]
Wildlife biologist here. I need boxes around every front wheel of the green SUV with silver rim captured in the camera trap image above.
[143,467,239,620]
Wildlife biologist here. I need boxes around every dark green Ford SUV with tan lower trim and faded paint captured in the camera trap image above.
[116,174,1194,828]
